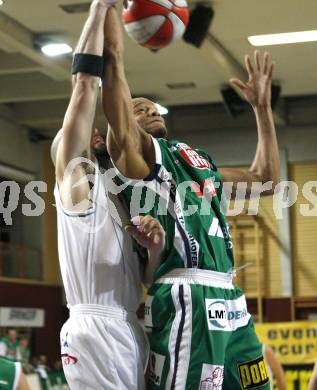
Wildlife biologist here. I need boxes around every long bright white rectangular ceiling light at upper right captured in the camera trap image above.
[248,30,317,46]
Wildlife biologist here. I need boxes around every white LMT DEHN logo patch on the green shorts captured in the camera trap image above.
[205,296,250,332]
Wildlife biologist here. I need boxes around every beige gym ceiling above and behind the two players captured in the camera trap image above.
[0,0,317,137]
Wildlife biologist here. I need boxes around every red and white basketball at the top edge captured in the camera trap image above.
[123,0,189,50]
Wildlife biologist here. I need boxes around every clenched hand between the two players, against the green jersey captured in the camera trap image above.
[125,215,165,255]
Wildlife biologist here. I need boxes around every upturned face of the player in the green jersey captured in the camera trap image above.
[133,98,167,138]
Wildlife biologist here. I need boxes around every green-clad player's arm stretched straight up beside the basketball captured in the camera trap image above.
[103,8,154,179]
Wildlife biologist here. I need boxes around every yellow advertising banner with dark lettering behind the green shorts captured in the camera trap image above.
[255,321,317,365]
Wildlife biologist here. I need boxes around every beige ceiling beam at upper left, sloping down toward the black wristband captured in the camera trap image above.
[0,12,70,80]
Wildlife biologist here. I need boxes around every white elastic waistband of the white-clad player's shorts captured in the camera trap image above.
[69,304,138,322]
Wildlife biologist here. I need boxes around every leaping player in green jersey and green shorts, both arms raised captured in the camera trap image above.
[103,4,279,390]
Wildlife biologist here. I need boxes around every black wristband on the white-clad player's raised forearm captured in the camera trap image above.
[72,53,104,78]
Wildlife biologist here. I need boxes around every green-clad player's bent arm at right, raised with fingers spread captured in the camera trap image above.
[219,51,280,198]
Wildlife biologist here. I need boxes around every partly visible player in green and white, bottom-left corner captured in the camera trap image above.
[0,358,30,390]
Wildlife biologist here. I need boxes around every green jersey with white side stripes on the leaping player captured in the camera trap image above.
[115,139,233,279]
